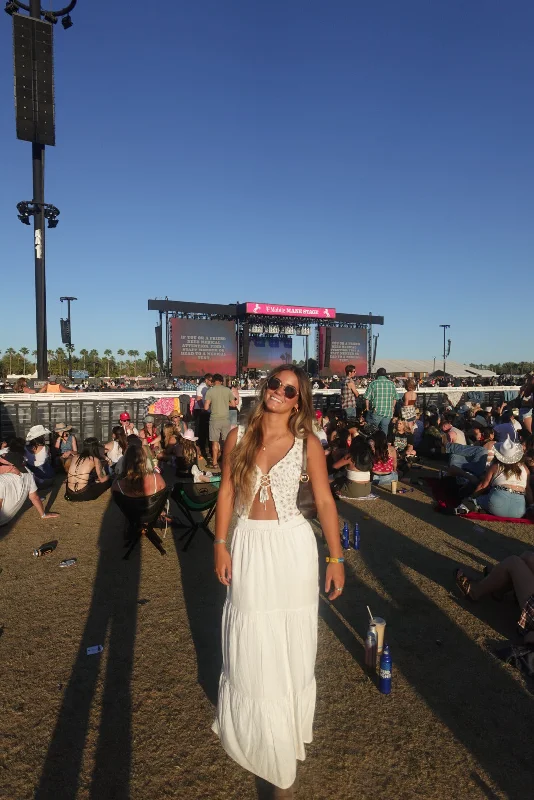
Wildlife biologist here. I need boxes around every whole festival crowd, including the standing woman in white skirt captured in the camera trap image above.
[0,365,534,798]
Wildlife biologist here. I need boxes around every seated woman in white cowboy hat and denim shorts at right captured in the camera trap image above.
[472,437,532,519]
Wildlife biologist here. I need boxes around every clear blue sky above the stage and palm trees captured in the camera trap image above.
[0,0,534,363]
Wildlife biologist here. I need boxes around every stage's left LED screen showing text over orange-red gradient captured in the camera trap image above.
[171,318,237,377]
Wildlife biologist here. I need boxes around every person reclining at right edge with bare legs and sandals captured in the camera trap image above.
[454,552,534,645]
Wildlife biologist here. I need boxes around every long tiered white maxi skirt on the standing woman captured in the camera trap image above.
[213,514,319,789]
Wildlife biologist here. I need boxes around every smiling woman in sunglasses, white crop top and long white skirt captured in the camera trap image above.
[213,366,345,798]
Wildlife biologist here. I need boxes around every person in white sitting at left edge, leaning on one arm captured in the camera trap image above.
[0,444,59,525]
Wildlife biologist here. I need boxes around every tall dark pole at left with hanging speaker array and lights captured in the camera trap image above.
[5,0,77,380]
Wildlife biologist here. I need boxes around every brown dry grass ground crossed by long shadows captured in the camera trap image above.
[0,468,534,800]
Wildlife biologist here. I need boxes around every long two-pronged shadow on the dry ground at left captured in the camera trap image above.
[35,501,141,800]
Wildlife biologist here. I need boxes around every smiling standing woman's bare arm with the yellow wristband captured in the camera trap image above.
[308,436,345,600]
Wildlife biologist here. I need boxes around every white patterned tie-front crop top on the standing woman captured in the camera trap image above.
[236,425,304,523]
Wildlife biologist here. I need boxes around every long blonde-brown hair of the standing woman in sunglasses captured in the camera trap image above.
[230,364,313,505]
